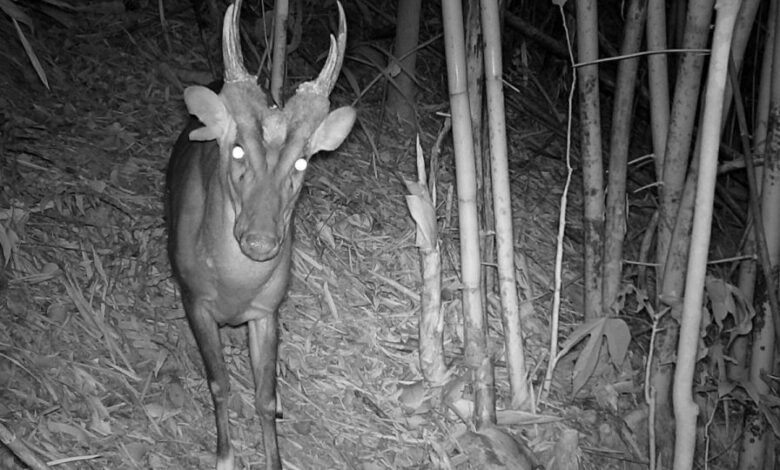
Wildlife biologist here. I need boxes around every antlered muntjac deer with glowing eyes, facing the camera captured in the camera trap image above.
[166,0,355,470]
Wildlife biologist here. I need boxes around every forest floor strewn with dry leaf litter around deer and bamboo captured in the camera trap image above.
[0,1,664,469]
